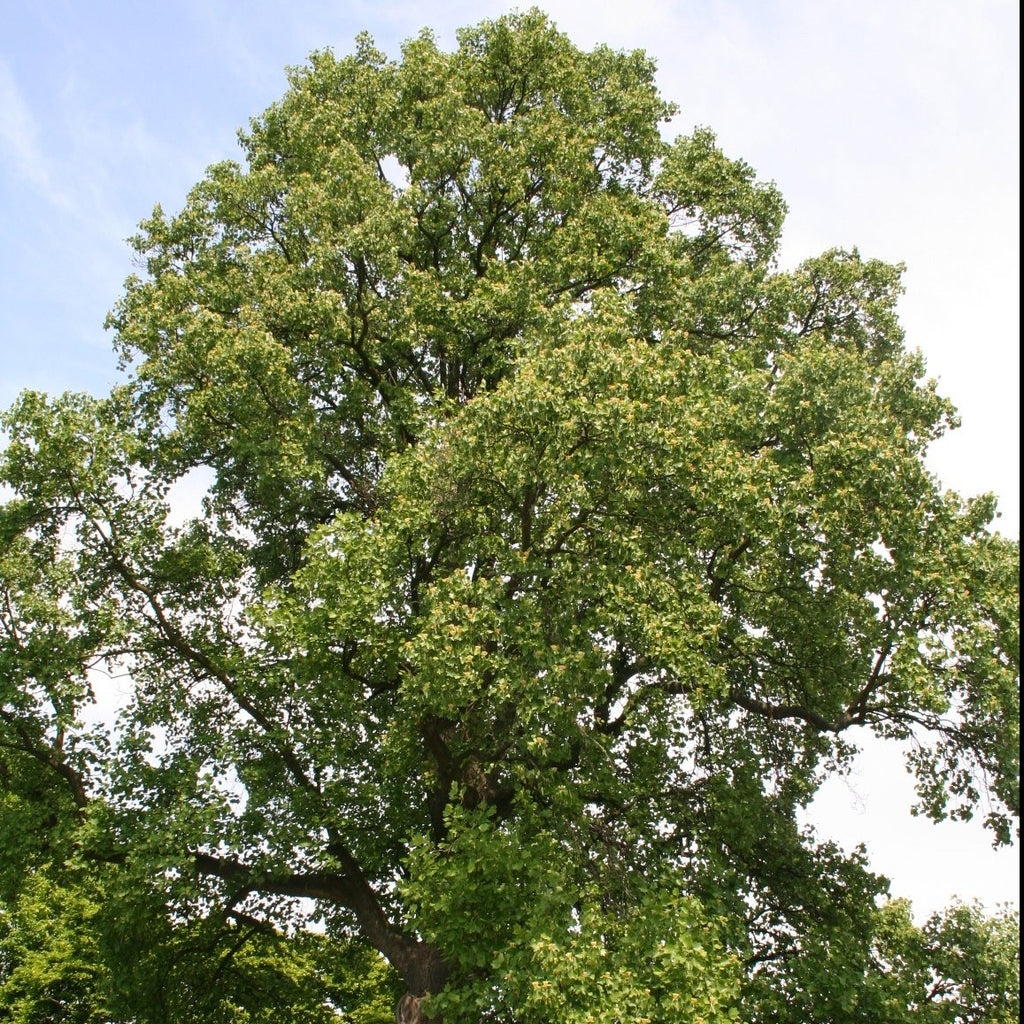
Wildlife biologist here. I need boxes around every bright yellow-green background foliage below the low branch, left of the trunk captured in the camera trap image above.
[0,871,397,1024]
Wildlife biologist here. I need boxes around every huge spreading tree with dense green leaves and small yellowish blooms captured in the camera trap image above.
[0,11,1019,1024]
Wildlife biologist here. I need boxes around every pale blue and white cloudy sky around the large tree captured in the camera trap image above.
[0,0,1020,916]
